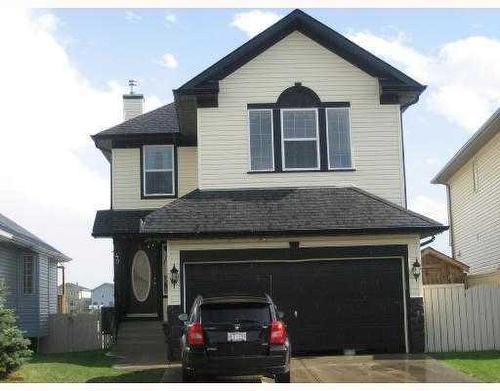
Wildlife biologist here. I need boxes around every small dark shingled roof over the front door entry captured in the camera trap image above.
[92,209,153,237]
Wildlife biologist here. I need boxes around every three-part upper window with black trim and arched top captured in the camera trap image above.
[248,83,352,172]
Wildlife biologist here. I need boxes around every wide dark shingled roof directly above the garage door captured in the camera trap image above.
[141,187,447,237]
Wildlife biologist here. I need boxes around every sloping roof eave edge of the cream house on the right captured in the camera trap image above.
[431,109,500,185]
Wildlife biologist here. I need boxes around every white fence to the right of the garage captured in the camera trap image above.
[424,284,500,352]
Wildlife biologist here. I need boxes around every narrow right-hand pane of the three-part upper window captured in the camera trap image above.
[326,107,352,169]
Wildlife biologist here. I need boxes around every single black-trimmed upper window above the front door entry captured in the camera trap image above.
[143,145,175,196]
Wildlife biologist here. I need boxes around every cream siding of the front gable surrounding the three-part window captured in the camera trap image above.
[198,32,404,205]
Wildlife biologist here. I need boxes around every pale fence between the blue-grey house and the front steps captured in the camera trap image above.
[39,312,113,353]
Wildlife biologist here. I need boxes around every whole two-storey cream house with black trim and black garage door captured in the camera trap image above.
[93,10,446,357]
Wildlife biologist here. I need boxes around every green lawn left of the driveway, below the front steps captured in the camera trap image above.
[8,351,164,383]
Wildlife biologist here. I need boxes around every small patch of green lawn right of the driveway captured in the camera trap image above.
[433,351,500,382]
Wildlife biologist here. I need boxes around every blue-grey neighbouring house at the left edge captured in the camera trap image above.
[0,214,71,338]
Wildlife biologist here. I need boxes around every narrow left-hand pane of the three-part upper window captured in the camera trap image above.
[248,109,274,171]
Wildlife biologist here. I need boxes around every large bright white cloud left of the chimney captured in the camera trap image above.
[0,9,158,285]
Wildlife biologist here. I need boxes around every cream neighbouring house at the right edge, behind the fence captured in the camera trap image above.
[432,109,500,281]
